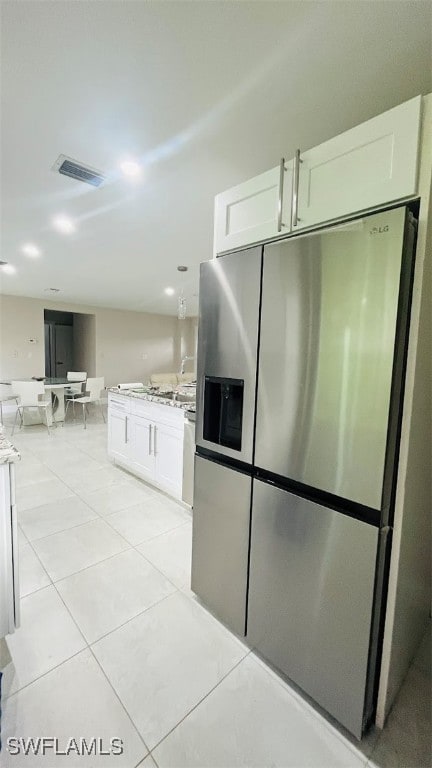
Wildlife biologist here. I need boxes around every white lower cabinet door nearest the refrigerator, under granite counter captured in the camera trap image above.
[153,424,183,499]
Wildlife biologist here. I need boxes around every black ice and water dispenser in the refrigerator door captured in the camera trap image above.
[203,376,244,451]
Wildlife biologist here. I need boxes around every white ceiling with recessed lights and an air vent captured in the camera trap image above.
[1,0,432,315]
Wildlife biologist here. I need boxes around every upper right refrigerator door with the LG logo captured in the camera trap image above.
[255,208,412,510]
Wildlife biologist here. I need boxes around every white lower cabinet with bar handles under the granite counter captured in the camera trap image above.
[108,393,184,499]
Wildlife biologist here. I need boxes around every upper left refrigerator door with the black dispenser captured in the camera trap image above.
[196,247,262,464]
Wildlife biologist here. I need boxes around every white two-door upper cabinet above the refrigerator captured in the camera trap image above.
[214,96,422,255]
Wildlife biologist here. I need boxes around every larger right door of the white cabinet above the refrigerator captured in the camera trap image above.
[293,96,421,231]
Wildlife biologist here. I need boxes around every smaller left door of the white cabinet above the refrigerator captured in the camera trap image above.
[214,160,293,254]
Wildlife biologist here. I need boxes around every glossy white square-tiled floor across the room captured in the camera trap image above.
[0,421,430,768]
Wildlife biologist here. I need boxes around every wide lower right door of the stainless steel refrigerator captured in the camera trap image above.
[247,480,379,738]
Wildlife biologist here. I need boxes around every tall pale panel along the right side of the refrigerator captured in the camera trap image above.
[376,96,432,728]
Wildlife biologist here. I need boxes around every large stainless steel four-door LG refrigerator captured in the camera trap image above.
[192,206,416,738]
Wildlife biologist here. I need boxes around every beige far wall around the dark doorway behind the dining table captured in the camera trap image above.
[0,295,193,386]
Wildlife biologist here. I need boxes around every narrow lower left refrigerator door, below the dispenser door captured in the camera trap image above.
[192,456,252,635]
